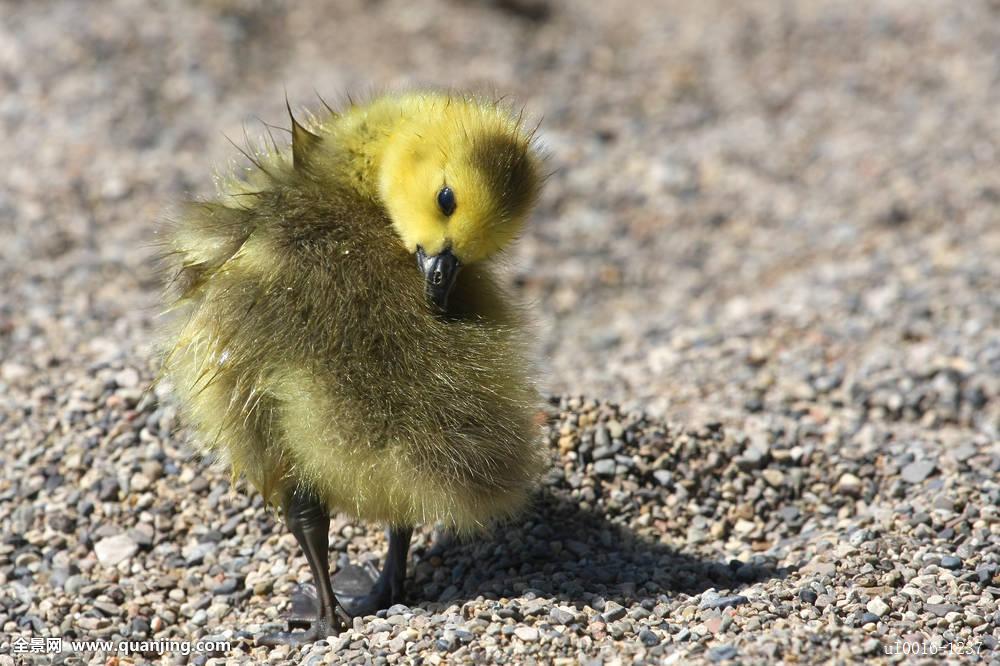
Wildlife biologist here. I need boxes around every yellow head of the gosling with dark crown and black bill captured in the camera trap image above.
[379,100,542,309]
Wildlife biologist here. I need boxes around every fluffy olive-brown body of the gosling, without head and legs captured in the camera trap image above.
[164,173,544,530]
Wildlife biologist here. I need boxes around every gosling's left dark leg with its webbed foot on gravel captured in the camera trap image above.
[258,490,349,646]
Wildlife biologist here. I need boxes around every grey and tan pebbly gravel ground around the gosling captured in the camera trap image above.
[0,0,1000,664]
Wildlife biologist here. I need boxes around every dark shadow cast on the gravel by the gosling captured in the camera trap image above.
[407,489,780,608]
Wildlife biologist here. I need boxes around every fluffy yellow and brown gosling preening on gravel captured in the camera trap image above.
[163,93,546,645]
